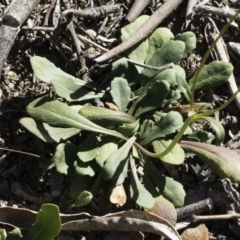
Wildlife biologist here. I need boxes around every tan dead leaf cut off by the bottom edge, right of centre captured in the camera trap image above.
[181,224,209,240]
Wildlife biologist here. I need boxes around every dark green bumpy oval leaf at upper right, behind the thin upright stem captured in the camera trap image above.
[189,61,233,91]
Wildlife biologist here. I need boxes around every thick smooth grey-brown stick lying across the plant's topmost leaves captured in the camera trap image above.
[95,0,183,63]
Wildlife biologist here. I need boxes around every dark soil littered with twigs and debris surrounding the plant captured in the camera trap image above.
[0,0,240,240]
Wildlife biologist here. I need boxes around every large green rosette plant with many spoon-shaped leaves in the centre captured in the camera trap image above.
[20,13,240,217]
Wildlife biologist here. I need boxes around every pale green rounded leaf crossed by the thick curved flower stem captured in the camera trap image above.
[152,140,185,165]
